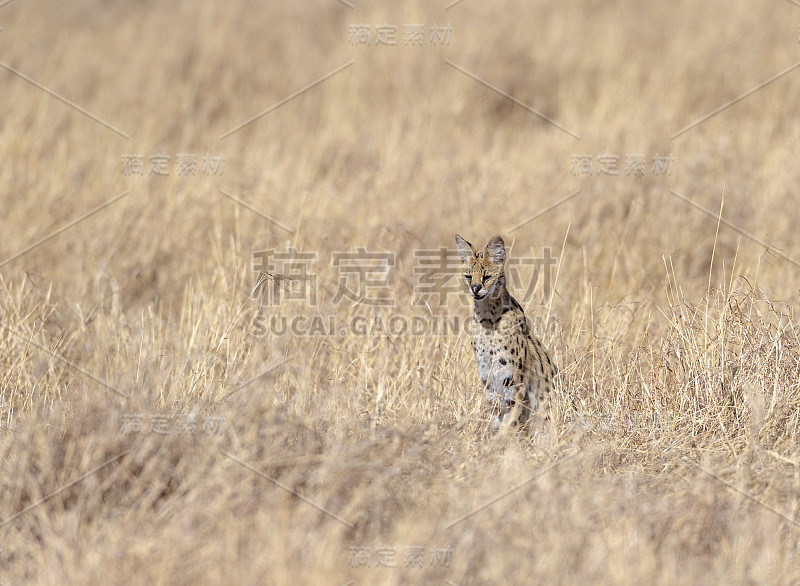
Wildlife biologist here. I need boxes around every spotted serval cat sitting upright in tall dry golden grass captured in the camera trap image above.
[456,234,556,428]
